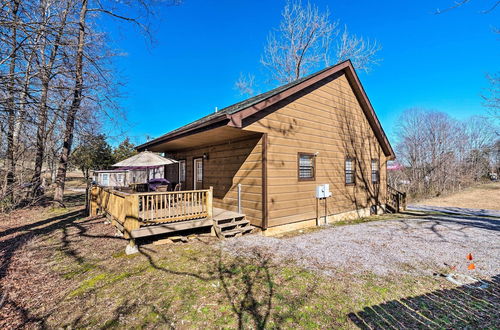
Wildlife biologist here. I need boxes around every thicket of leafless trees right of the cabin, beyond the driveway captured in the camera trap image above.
[393,109,496,196]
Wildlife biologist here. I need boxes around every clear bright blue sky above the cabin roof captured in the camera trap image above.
[103,0,500,144]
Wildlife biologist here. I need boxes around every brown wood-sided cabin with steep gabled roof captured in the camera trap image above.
[137,61,394,233]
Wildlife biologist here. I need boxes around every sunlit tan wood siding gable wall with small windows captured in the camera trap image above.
[244,75,387,227]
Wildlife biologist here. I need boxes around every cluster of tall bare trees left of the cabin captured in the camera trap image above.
[0,0,180,207]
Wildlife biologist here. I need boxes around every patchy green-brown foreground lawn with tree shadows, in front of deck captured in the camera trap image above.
[0,192,499,329]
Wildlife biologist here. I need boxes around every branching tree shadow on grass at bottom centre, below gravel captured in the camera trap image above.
[139,240,316,329]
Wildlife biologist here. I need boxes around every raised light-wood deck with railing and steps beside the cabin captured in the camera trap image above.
[90,186,253,239]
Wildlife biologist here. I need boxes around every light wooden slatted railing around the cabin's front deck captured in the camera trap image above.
[90,186,213,237]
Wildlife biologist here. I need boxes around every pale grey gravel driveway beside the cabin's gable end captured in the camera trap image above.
[222,208,500,277]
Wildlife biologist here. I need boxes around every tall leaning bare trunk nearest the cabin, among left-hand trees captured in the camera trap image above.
[54,0,88,204]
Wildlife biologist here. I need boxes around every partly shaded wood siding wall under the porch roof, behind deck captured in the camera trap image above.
[167,134,262,226]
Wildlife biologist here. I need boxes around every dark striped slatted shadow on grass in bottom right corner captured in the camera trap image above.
[348,275,500,329]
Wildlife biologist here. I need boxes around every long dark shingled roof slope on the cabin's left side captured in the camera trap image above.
[139,62,336,147]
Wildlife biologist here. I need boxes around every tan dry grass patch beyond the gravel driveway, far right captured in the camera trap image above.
[417,182,500,210]
